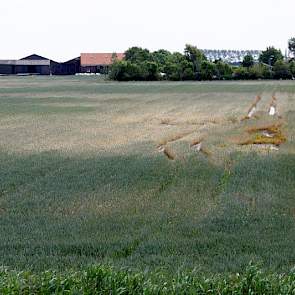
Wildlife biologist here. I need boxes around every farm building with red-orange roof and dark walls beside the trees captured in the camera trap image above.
[81,53,124,74]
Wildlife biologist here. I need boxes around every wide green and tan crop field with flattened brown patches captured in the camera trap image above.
[0,77,295,274]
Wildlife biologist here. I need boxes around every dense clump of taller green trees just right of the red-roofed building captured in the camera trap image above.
[110,45,233,81]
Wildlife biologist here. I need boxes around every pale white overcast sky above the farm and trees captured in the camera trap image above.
[0,0,295,61]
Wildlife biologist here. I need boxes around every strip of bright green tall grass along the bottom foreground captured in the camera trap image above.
[0,265,295,295]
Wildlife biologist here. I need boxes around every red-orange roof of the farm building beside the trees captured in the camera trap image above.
[81,53,124,66]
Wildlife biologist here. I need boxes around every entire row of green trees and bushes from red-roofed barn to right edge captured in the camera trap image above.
[109,38,295,81]
